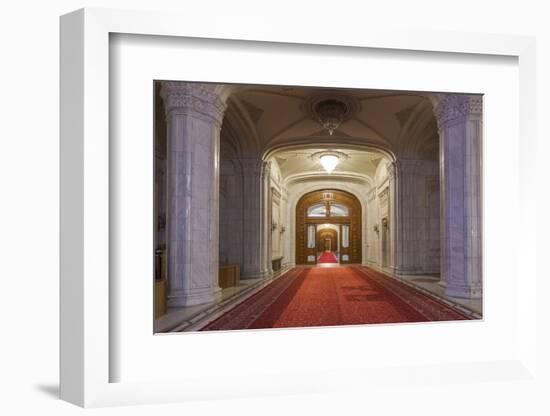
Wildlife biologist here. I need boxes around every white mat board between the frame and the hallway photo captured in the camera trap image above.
[110,35,520,384]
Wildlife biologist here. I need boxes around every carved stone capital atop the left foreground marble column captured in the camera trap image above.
[160,81,227,127]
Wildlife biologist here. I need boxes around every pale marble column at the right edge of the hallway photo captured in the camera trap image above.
[435,94,482,298]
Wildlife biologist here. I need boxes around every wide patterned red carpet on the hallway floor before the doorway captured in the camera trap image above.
[202,267,470,331]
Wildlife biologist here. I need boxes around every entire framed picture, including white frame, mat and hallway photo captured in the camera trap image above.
[61,9,537,407]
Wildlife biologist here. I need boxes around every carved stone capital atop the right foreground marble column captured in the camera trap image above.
[434,94,483,130]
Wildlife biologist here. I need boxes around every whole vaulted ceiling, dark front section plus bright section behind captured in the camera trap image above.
[221,85,439,183]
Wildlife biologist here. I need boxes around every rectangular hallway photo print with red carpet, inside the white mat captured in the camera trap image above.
[154,81,483,333]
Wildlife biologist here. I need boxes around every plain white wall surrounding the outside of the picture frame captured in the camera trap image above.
[0,0,550,415]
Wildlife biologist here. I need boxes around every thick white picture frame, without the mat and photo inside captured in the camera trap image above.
[60,9,538,407]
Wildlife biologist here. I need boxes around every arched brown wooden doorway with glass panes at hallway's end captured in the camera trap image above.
[296,189,361,265]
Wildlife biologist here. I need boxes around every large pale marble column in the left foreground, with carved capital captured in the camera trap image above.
[161,82,226,306]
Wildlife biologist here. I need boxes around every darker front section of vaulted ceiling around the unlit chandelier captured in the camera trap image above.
[222,86,438,159]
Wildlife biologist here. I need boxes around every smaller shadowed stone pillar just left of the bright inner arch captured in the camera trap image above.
[239,158,270,279]
